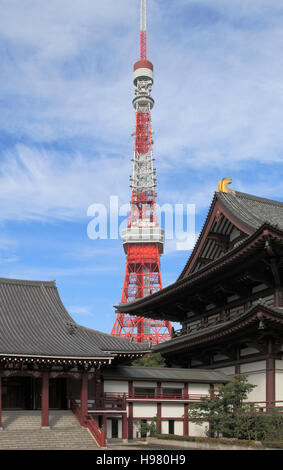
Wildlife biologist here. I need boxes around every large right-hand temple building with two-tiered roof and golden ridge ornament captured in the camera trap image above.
[117,178,283,409]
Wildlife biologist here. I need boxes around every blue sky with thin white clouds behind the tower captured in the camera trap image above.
[0,0,283,332]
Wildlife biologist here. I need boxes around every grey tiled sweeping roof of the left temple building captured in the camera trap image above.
[0,279,151,359]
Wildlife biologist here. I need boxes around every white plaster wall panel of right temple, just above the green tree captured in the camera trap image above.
[240,361,266,401]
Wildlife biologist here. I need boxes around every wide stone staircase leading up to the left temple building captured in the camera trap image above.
[0,410,99,450]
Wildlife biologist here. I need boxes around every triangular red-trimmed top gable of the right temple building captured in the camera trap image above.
[178,186,283,279]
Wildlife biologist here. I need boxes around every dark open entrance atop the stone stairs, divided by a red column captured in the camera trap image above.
[2,377,67,410]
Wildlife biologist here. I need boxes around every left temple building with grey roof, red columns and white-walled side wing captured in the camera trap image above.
[0,279,230,447]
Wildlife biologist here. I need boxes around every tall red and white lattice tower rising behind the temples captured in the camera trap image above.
[111,0,172,344]
